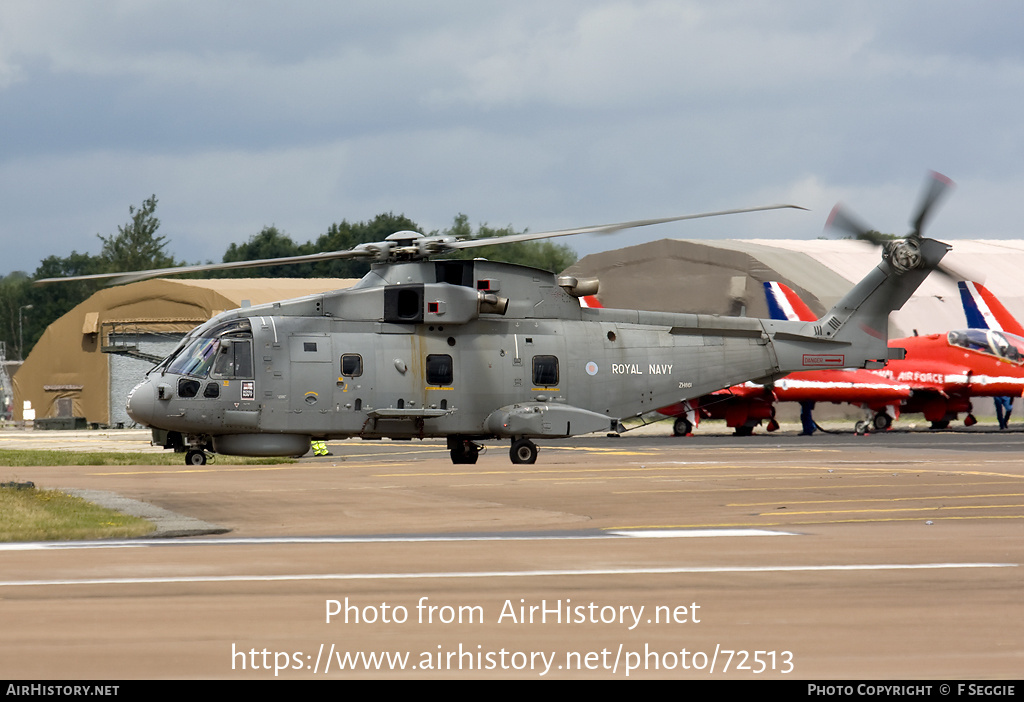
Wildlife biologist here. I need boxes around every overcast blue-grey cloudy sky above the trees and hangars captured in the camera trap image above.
[0,0,1024,273]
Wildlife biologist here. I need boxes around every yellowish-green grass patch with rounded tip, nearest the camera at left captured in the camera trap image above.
[0,487,157,541]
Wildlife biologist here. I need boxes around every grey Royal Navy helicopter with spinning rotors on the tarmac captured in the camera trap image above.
[41,196,949,465]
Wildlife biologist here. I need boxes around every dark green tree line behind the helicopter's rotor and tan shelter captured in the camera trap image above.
[0,195,577,360]
